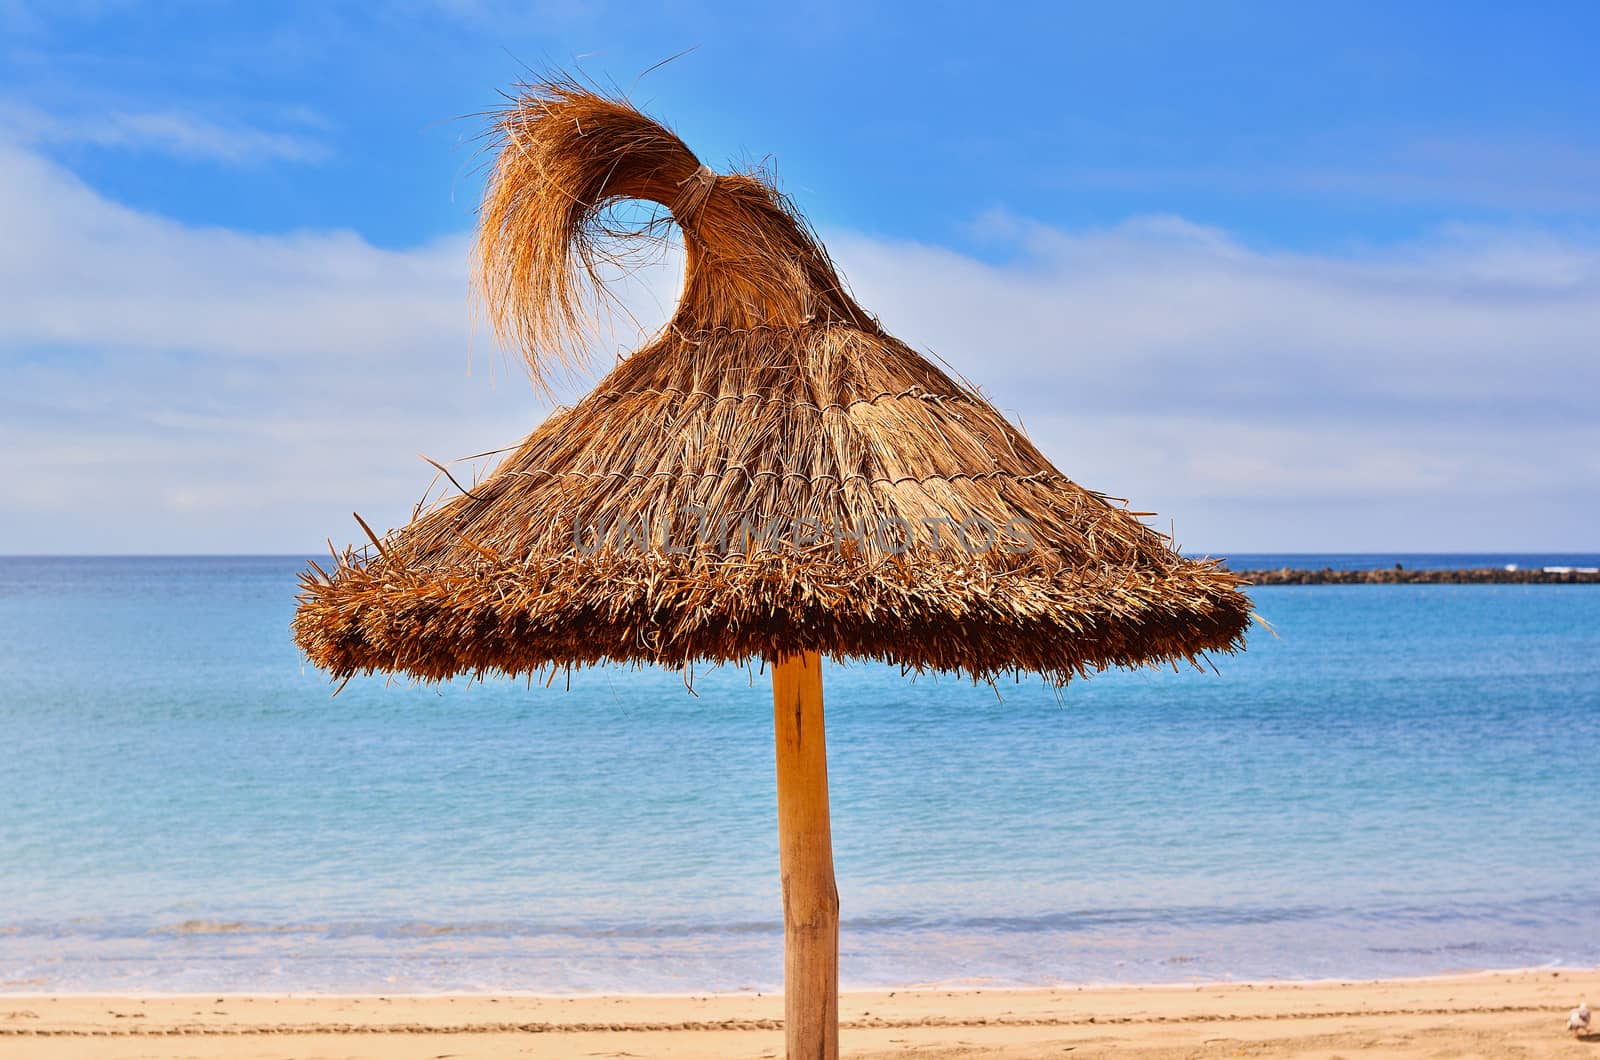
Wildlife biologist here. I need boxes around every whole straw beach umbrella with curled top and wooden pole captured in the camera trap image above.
[294,80,1250,1057]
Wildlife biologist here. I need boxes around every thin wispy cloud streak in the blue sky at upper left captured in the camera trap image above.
[0,102,330,165]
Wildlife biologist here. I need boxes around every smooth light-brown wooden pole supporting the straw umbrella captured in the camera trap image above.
[773,652,838,1060]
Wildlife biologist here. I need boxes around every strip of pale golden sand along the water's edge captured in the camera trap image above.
[0,970,1600,1060]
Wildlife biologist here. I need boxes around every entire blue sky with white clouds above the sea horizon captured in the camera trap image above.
[0,0,1600,552]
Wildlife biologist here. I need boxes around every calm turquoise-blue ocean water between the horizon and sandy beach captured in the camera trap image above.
[0,556,1600,991]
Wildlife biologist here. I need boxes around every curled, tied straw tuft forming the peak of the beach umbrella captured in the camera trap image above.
[475,78,878,390]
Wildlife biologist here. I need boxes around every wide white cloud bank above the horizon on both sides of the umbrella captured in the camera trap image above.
[0,140,1600,552]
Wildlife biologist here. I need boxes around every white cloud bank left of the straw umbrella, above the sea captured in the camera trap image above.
[0,140,677,554]
